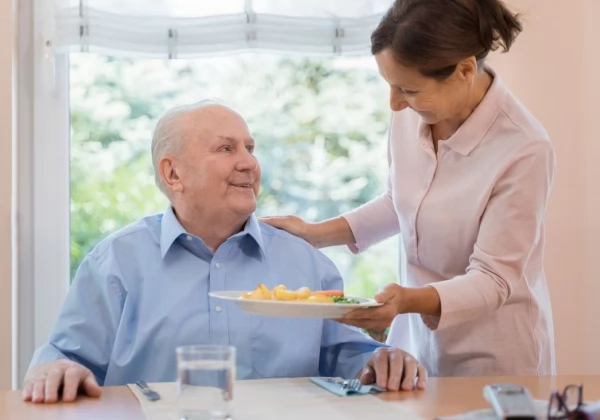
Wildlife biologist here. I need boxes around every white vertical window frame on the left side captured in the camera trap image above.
[12,0,70,388]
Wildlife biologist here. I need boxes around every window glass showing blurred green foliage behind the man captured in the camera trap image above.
[70,53,398,296]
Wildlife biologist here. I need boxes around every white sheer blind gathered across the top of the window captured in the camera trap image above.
[50,0,392,58]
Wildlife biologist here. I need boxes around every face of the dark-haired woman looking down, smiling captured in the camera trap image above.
[375,49,473,125]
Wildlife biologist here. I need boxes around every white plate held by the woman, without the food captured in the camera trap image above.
[208,290,381,318]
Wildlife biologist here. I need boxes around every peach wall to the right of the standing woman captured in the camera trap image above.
[491,0,600,374]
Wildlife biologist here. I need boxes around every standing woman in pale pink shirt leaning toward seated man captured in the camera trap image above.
[264,0,555,376]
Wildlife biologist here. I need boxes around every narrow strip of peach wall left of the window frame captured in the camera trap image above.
[0,0,14,389]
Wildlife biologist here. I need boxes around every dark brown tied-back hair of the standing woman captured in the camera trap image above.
[371,0,523,80]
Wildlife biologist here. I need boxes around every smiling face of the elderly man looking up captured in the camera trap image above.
[170,106,261,219]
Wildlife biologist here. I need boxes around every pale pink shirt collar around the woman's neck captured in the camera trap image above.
[419,66,506,156]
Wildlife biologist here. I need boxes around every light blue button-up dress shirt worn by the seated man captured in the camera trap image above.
[31,207,383,385]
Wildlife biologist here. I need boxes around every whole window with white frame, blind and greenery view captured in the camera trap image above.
[15,0,398,384]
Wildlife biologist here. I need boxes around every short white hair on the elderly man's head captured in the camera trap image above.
[152,99,225,197]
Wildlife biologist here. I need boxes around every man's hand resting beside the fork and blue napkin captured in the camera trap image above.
[358,347,427,391]
